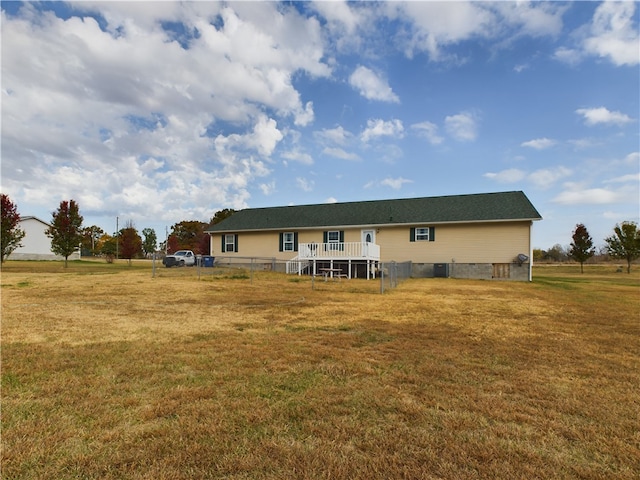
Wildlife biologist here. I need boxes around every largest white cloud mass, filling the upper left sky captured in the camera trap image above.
[2,2,331,221]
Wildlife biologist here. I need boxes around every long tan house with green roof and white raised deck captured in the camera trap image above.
[205,191,542,280]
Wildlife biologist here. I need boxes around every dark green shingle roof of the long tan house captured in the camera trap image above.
[206,191,542,233]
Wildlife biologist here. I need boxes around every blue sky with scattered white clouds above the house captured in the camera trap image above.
[0,1,640,249]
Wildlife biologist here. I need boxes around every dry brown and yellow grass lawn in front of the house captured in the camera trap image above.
[2,262,640,479]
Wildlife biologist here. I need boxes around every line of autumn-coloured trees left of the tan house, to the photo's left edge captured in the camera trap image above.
[0,194,235,267]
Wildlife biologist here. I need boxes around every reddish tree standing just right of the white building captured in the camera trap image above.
[45,200,83,268]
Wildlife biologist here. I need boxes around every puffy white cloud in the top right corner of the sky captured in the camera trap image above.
[584,2,640,66]
